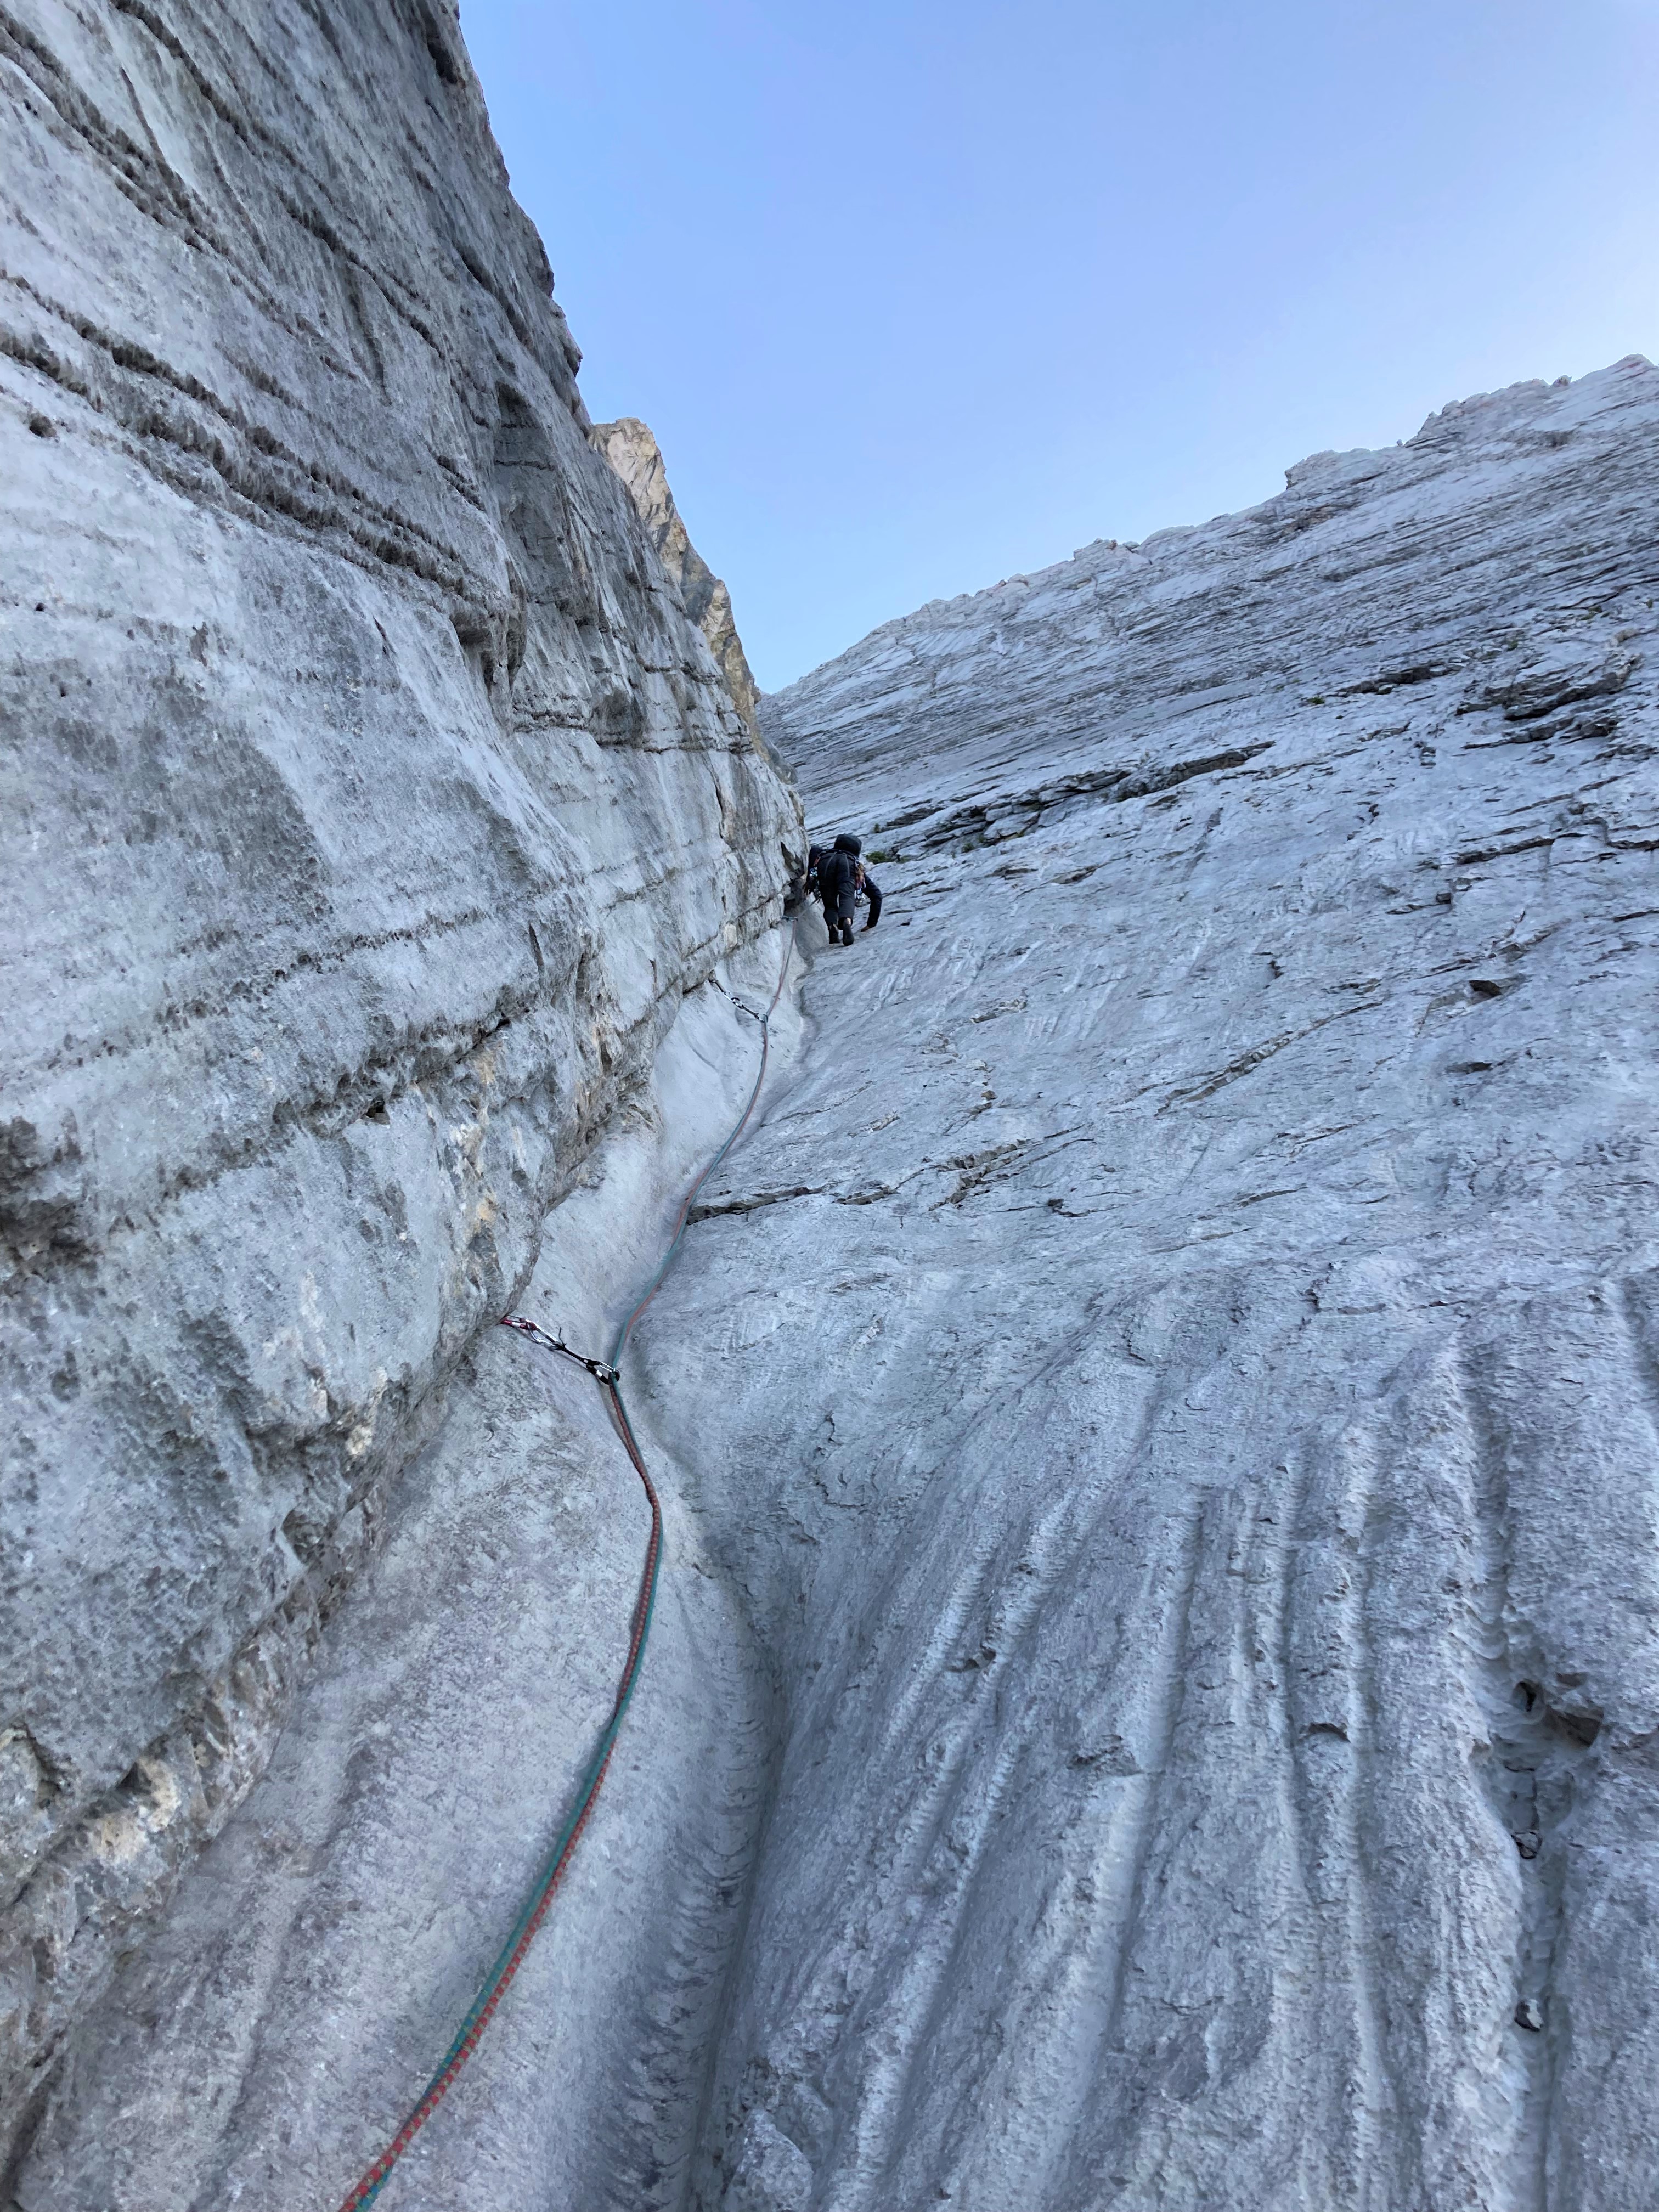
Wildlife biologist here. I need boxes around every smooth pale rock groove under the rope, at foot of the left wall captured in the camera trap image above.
[13,955,794,2212]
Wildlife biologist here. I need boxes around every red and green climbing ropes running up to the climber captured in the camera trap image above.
[341,927,794,2212]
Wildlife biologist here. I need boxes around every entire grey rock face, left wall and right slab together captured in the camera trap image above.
[0,7,1659,2212]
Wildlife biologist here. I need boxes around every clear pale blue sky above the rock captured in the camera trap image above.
[462,0,1659,690]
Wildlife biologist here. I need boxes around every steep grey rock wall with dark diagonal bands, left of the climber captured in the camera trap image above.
[0,0,799,2159]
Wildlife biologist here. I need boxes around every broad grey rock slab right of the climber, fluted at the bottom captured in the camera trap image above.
[690,360,1659,2212]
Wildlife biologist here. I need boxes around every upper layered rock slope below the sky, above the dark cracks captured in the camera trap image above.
[761,356,1655,847]
